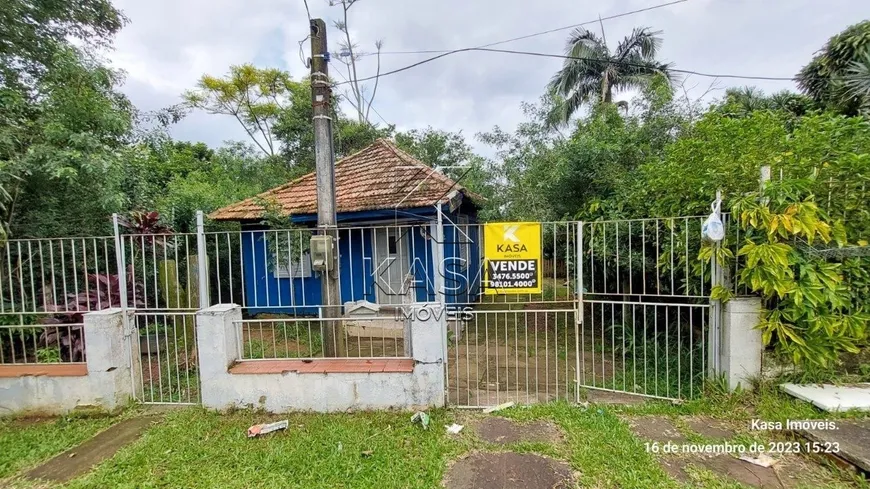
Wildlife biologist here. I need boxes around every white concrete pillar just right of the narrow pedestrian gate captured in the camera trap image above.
[196,304,242,409]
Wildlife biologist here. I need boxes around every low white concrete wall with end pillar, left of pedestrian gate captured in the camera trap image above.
[0,309,133,414]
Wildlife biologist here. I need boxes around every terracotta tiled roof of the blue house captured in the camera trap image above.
[209,139,483,221]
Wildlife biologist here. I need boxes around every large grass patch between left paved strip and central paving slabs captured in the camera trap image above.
[69,408,465,489]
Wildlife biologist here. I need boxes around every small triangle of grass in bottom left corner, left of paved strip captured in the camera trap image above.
[0,416,116,479]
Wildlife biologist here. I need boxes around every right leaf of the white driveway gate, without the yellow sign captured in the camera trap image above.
[577,217,715,399]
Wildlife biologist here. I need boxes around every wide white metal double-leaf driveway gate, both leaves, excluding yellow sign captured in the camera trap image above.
[446,217,717,407]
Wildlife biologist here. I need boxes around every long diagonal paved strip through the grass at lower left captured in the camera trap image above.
[25,416,159,483]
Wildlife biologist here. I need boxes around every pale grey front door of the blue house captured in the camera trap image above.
[374,227,411,304]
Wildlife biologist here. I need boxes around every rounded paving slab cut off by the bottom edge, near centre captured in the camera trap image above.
[444,452,576,489]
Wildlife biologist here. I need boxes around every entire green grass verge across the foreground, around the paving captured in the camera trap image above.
[0,383,868,489]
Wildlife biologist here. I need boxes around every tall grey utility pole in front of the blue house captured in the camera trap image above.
[310,19,346,357]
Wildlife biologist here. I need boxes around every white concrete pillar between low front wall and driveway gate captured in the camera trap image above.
[409,302,447,407]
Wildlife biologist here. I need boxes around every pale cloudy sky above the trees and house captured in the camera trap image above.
[108,0,870,153]
